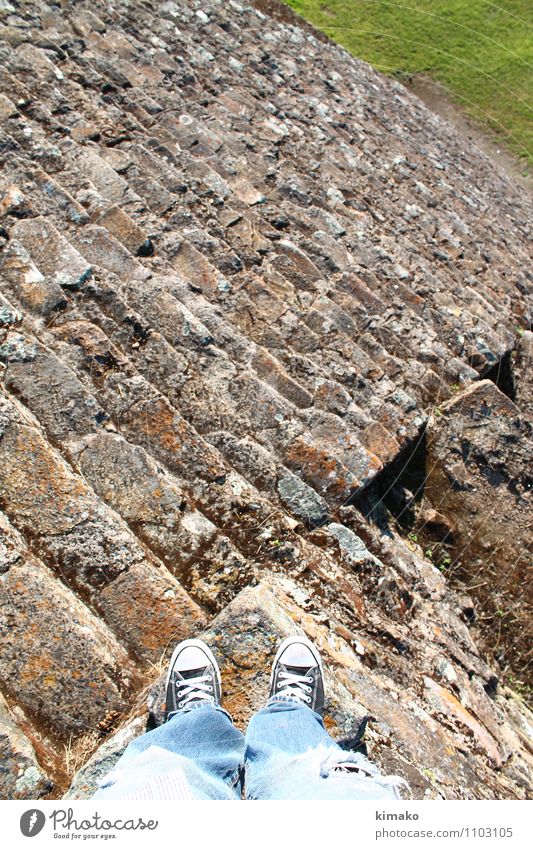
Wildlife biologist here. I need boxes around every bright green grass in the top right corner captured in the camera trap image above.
[286,0,533,167]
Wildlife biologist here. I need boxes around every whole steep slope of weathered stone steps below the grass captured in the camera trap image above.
[0,0,532,798]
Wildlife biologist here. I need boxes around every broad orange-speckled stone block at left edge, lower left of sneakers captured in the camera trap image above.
[0,506,140,740]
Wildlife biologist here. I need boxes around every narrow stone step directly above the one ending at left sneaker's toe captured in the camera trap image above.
[0,313,254,609]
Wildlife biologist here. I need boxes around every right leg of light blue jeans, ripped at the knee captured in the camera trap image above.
[244,697,403,799]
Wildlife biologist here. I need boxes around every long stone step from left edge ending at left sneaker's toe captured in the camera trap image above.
[0,395,207,661]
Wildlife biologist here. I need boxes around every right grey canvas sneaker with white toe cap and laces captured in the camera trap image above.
[270,637,324,714]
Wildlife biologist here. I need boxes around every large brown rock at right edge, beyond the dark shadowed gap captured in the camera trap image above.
[424,380,533,667]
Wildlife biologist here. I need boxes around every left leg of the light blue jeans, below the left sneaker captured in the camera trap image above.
[93,705,244,799]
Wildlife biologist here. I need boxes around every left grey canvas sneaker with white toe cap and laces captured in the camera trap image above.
[165,640,222,719]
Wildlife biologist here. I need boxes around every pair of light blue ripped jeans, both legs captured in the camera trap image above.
[93,697,404,800]
